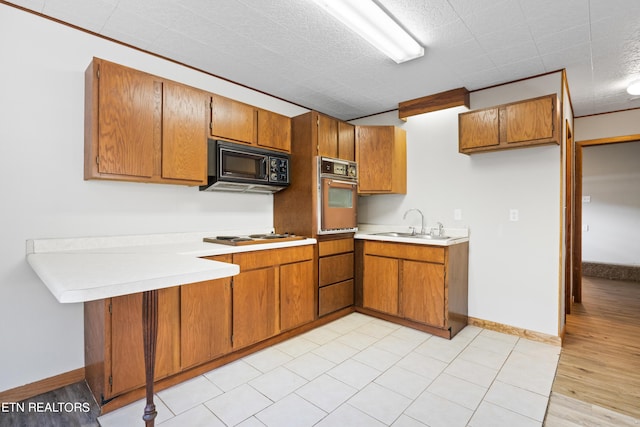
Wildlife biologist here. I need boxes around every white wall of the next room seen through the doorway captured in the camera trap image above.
[582,141,640,266]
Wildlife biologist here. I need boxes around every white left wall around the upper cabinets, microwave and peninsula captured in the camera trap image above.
[0,4,305,391]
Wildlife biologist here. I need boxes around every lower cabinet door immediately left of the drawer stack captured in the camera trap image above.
[280,260,316,331]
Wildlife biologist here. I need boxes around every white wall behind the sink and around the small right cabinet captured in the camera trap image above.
[354,73,561,342]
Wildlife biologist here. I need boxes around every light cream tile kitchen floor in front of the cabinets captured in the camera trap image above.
[98,313,560,427]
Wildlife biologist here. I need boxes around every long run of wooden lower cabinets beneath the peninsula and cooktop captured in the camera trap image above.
[84,245,317,406]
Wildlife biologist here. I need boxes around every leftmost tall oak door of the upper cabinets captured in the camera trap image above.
[97,61,162,178]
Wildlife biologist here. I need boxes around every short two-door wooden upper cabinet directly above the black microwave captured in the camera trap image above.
[210,94,291,152]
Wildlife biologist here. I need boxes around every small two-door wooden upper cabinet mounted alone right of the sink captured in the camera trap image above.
[458,94,560,154]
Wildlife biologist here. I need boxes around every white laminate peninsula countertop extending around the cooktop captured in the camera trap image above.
[27,233,316,303]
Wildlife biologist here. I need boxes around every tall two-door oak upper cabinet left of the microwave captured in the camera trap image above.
[84,58,207,185]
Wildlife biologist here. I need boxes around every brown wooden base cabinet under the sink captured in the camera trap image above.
[356,240,469,338]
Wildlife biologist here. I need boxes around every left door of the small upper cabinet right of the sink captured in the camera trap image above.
[458,108,500,152]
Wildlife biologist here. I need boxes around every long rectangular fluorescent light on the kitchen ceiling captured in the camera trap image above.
[313,0,424,64]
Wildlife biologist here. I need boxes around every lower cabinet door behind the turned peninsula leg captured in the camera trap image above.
[105,286,180,398]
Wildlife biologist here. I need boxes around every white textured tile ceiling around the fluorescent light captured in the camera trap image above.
[11,0,640,120]
